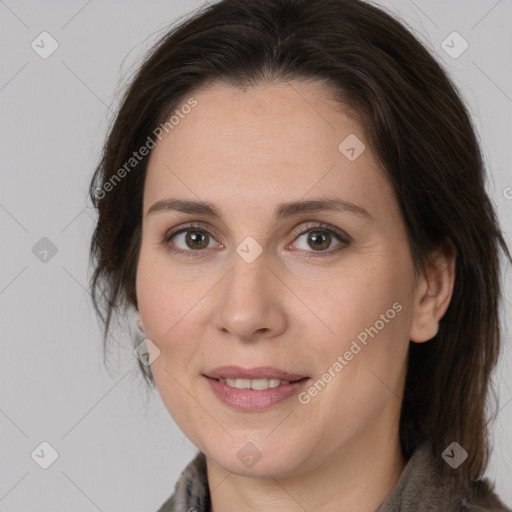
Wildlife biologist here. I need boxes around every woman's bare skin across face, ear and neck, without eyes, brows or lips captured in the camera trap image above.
[136,81,454,512]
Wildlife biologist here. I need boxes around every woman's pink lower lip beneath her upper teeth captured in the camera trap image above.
[206,377,309,411]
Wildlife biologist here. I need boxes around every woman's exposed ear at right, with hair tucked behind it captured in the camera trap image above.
[409,238,457,343]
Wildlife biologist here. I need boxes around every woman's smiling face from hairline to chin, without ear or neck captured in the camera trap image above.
[136,82,424,476]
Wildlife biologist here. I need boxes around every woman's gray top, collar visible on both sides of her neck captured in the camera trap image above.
[158,444,512,512]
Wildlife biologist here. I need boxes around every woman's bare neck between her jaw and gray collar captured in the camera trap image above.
[207,435,405,512]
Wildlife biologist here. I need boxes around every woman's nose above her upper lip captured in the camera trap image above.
[213,246,289,340]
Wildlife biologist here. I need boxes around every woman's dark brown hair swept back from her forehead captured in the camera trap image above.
[89,0,510,479]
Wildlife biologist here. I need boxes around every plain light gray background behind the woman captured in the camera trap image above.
[0,0,512,512]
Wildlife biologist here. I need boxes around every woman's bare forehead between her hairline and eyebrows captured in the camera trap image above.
[144,82,391,222]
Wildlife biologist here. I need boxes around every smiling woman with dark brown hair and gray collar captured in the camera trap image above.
[90,0,510,512]
